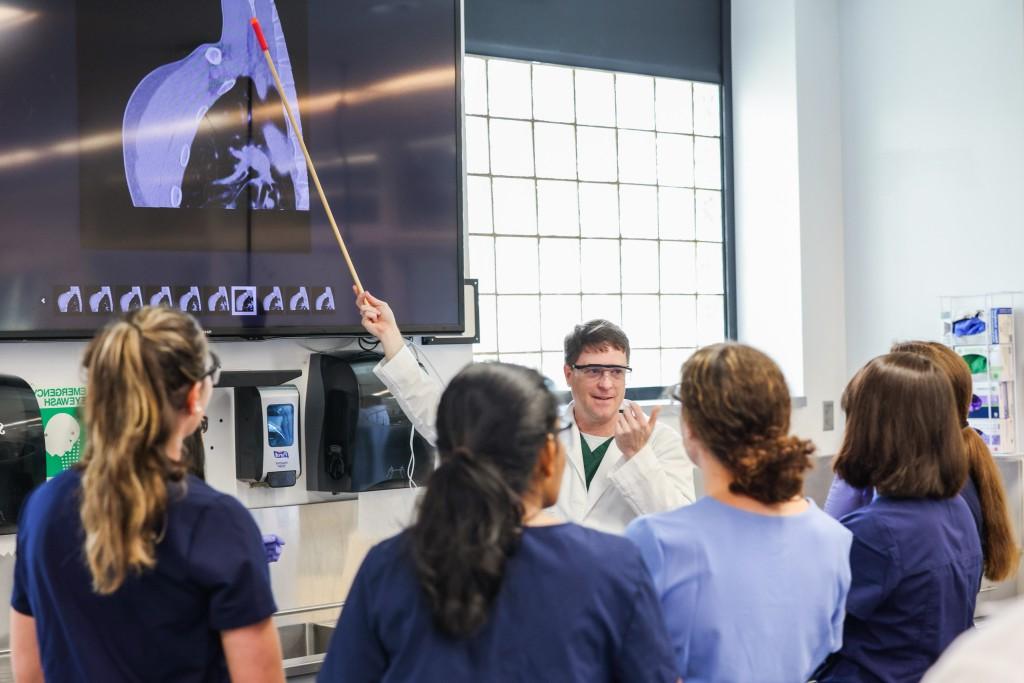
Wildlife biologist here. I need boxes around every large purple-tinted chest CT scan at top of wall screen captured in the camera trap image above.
[123,0,309,211]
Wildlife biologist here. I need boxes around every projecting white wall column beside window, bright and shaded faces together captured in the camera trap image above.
[732,0,846,455]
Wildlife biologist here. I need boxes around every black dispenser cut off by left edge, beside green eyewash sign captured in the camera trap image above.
[0,375,46,533]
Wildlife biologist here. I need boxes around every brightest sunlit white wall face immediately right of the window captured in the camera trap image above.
[732,0,804,395]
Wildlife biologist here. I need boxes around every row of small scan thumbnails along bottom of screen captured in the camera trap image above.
[56,285,335,315]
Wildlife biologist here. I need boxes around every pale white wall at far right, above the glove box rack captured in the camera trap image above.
[840,0,1024,371]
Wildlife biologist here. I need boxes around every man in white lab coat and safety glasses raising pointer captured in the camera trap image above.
[356,293,695,533]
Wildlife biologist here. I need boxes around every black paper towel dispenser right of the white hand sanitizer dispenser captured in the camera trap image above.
[305,352,433,493]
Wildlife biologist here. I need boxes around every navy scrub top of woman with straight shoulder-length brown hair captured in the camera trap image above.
[819,496,982,683]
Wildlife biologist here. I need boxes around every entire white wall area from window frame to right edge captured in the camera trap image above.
[732,0,1024,454]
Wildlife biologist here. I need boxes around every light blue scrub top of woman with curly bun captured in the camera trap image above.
[626,498,851,683]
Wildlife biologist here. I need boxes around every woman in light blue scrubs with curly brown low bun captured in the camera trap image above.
[626,343,851,683]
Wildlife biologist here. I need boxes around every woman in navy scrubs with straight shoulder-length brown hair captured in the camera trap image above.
[818,351,982,683]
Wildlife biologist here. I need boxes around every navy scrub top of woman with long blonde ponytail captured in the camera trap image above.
[11,470,276,683]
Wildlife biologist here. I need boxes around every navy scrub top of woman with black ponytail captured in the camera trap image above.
[317,524,677,683]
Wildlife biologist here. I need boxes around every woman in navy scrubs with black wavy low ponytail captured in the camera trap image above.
[318,362,678,683]
